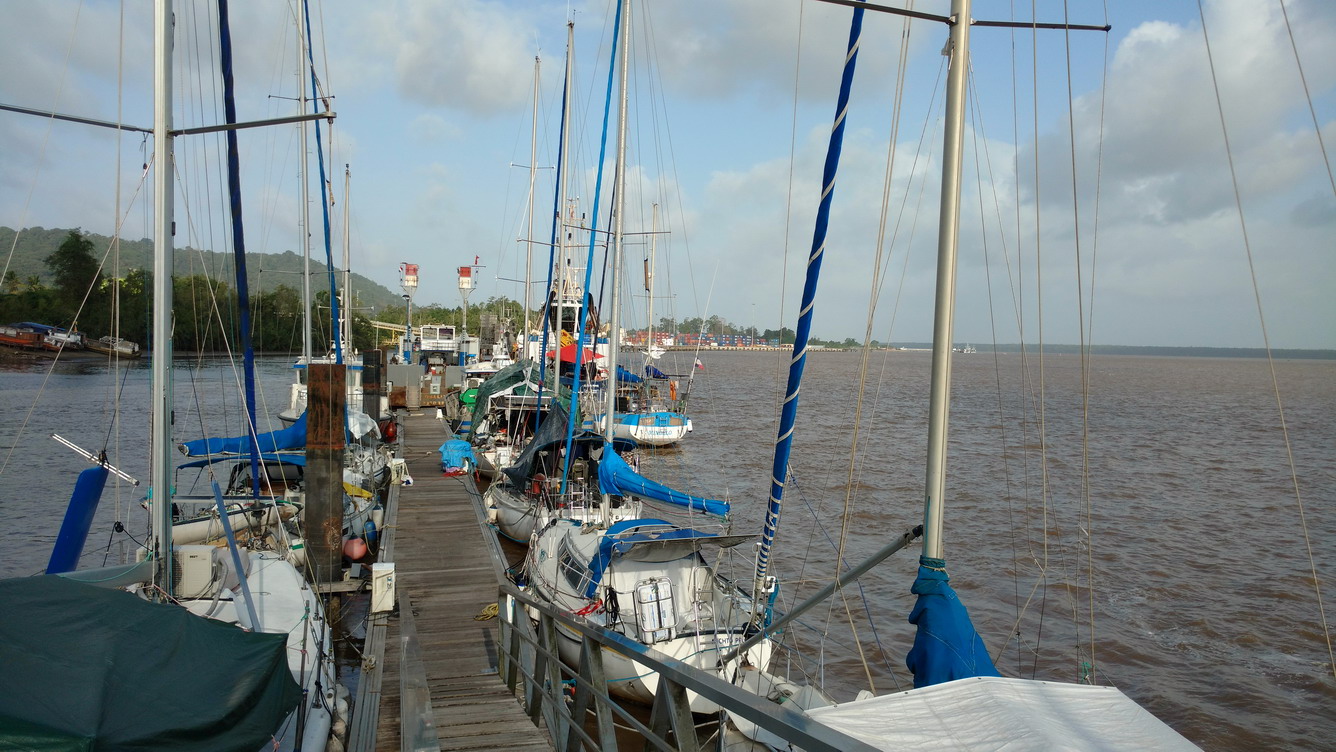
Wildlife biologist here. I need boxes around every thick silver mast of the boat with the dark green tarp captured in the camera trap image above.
[150,0,175,597]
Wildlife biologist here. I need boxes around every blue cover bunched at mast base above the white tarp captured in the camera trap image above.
[904,557,1002,688]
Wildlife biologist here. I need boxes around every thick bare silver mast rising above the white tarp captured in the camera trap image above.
[923,0,970,558]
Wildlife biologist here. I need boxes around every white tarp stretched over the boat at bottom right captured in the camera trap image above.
[808,677,1197,752]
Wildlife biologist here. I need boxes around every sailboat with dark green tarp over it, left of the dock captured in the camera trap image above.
[0,0,338,751]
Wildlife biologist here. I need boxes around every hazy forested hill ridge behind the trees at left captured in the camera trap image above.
[0,227,402,309]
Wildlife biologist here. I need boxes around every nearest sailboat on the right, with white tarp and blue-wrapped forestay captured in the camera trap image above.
[725,0,1196,749]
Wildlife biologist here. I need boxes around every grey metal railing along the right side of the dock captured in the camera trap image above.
[497,582,874,752]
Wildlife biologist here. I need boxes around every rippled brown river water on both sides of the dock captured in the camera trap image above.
[0,351,1336,749]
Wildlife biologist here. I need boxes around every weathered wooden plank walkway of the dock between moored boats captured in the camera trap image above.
[349,409,553,751]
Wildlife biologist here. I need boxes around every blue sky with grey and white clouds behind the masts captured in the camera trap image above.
[0,0,1336,347]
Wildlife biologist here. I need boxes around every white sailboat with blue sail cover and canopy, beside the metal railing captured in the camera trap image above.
[524,0,770,712]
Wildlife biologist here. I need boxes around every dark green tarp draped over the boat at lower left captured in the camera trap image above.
[0,574,302,751]
